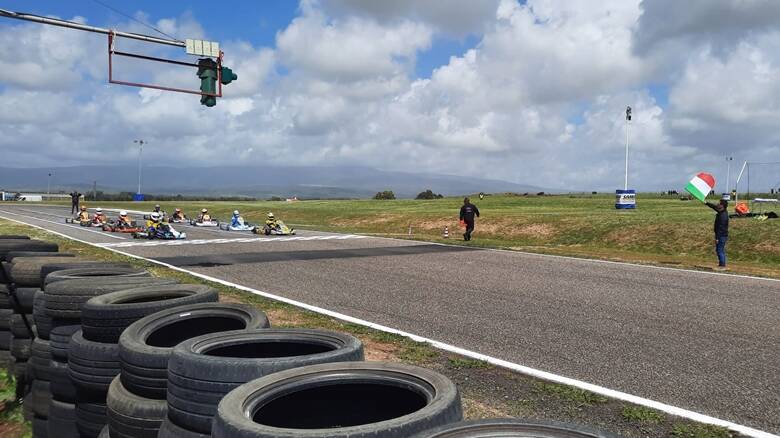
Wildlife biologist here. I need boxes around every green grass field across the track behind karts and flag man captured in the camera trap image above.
[51,194,780,277]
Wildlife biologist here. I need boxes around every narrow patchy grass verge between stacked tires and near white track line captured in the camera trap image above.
[0,220,737,438]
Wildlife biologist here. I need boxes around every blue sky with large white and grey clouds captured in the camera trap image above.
[0,0,780,191]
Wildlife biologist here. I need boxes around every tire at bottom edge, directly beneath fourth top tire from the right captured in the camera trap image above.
[106,377,168,438]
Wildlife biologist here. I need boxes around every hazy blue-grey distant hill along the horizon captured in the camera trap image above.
[0,166,556,198]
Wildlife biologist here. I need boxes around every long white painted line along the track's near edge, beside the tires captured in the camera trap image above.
[0,210,780,438]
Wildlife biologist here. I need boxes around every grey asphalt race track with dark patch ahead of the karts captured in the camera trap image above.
[0,205,780,434]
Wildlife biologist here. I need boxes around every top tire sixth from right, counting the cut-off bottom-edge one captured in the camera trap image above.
[45,277,176,319]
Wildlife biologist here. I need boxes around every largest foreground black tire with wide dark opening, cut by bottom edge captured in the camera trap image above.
[212,362,463,438]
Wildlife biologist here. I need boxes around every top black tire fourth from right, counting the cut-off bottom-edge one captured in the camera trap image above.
[119,303,269,399]
